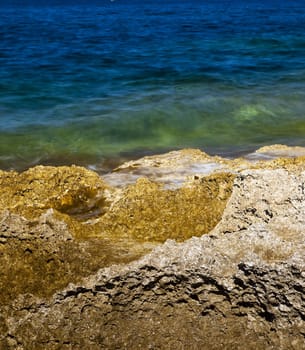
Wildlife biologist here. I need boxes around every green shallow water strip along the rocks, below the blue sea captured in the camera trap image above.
[0,89,305,171]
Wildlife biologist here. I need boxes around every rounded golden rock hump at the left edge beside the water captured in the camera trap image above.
[0,166,107,217]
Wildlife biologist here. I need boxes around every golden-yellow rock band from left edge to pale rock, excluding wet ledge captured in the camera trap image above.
[0,161,234,242]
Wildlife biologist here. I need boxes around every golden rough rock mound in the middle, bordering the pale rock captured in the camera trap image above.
[100,173,234,242]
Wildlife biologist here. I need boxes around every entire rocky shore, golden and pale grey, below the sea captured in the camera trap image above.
[0,145,305,350]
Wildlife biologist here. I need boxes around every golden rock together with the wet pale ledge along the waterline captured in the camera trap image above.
[0,145,305,242]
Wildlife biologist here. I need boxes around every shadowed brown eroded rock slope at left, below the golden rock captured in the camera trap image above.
[0,210,152,308]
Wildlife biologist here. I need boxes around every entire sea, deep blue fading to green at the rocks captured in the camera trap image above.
[0,0,305,170]
